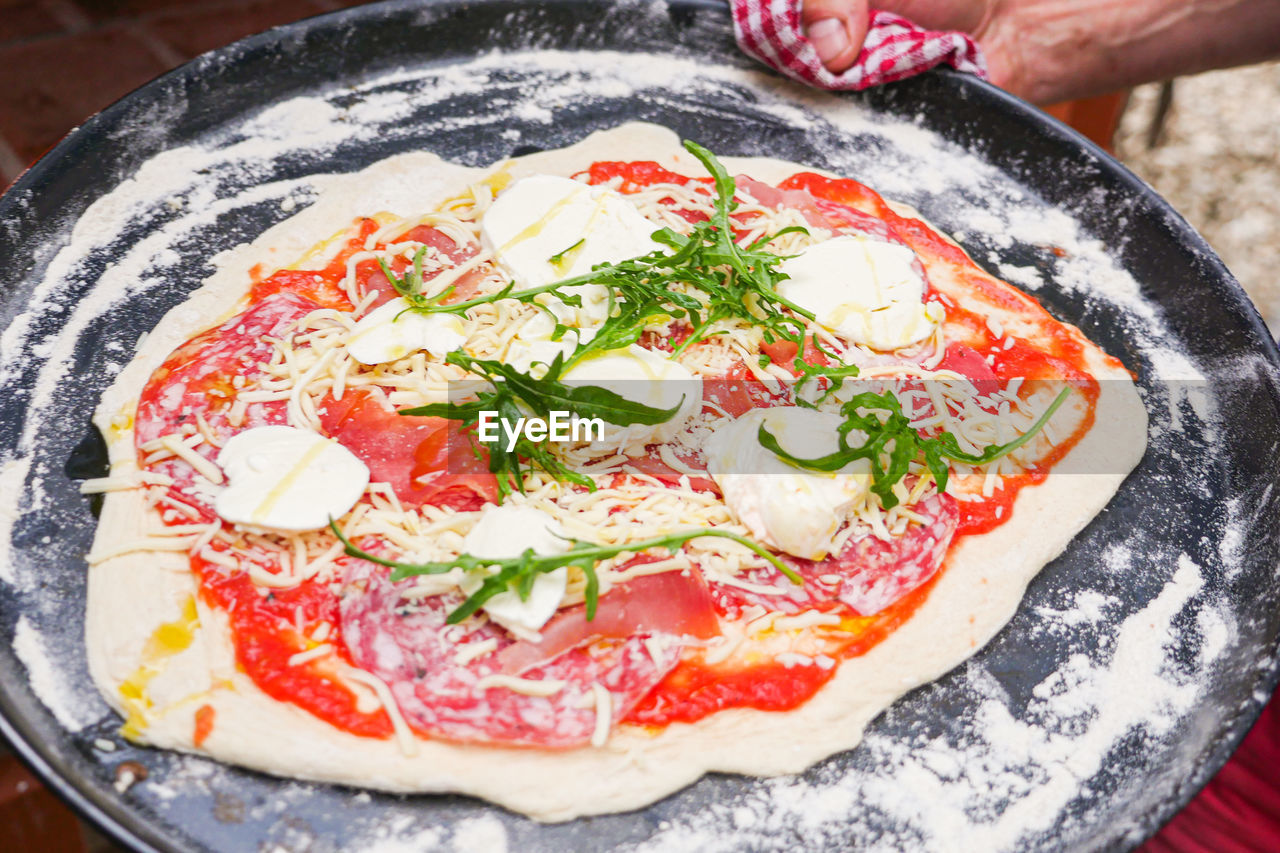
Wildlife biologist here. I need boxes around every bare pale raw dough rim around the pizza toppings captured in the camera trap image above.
[86,124,1147,821]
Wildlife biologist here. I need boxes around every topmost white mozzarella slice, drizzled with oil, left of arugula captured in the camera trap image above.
[480,174,662,328]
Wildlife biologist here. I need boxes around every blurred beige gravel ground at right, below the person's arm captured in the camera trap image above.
[1116,63,1280,334]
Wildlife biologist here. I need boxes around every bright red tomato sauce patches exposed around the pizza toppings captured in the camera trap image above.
[145,161,1098,738]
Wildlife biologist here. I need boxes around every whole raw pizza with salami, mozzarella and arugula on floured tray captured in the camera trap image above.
[86,124,1146,820]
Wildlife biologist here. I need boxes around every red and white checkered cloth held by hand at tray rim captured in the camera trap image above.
[730,0,987,90]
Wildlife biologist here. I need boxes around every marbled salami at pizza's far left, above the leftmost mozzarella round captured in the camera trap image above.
[134,292,319,520]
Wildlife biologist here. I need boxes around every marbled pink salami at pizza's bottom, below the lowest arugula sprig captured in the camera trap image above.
[339,561,682,748]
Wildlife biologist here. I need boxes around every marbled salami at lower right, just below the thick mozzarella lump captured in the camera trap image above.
[708,494,959,616]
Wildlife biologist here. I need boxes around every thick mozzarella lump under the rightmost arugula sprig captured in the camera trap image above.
[704,406,870,560]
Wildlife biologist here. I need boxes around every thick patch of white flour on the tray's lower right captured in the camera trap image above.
[640,556,1203,850]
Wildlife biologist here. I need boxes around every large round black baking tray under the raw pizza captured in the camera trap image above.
[0,0,1280,850]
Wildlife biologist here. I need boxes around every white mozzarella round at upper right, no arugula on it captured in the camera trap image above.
[778,236,941,351]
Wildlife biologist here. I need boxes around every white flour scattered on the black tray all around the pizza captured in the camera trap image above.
[0,43,1248,853]
